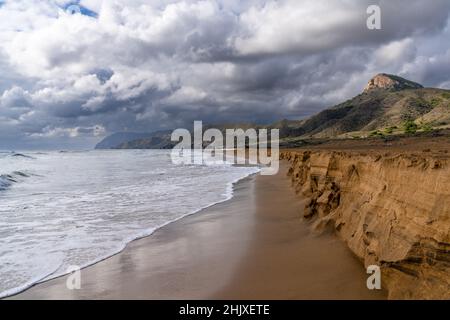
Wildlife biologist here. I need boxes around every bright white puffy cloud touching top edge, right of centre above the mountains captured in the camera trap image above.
[235,0,367,55]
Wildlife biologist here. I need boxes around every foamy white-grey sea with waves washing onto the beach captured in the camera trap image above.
[0,150,259,297]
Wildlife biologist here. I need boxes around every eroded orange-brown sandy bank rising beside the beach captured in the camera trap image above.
[281,151,450,299]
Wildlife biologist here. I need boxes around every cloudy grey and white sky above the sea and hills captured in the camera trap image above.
[0,0,450,150]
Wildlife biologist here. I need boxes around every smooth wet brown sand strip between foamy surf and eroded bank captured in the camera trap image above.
[12,162,386,299]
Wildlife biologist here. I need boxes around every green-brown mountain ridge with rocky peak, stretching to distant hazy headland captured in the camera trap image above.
[96,73,450,149]
